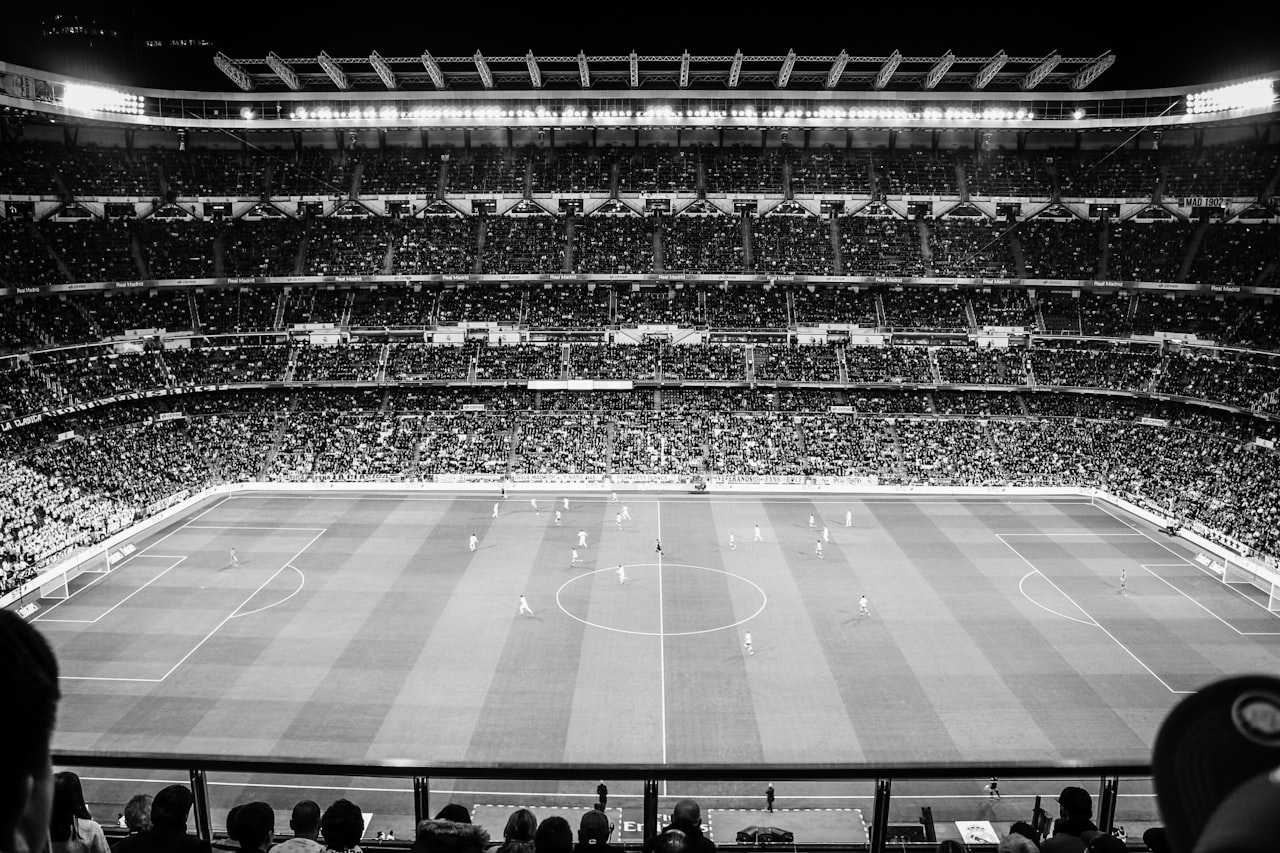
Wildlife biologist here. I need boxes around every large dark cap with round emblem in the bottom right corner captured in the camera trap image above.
[1151,675,1280,853]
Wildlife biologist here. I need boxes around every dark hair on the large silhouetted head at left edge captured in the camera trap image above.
[0,610,61,835]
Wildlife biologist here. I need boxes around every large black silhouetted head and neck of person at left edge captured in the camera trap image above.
[0,611,60,850]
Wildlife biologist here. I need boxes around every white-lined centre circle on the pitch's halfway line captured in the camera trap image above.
[556,561,768,637]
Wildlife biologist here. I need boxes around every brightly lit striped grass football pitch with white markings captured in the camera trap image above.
[36,492,1280,765]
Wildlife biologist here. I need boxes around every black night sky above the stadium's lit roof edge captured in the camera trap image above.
[0,0,1280,91]
